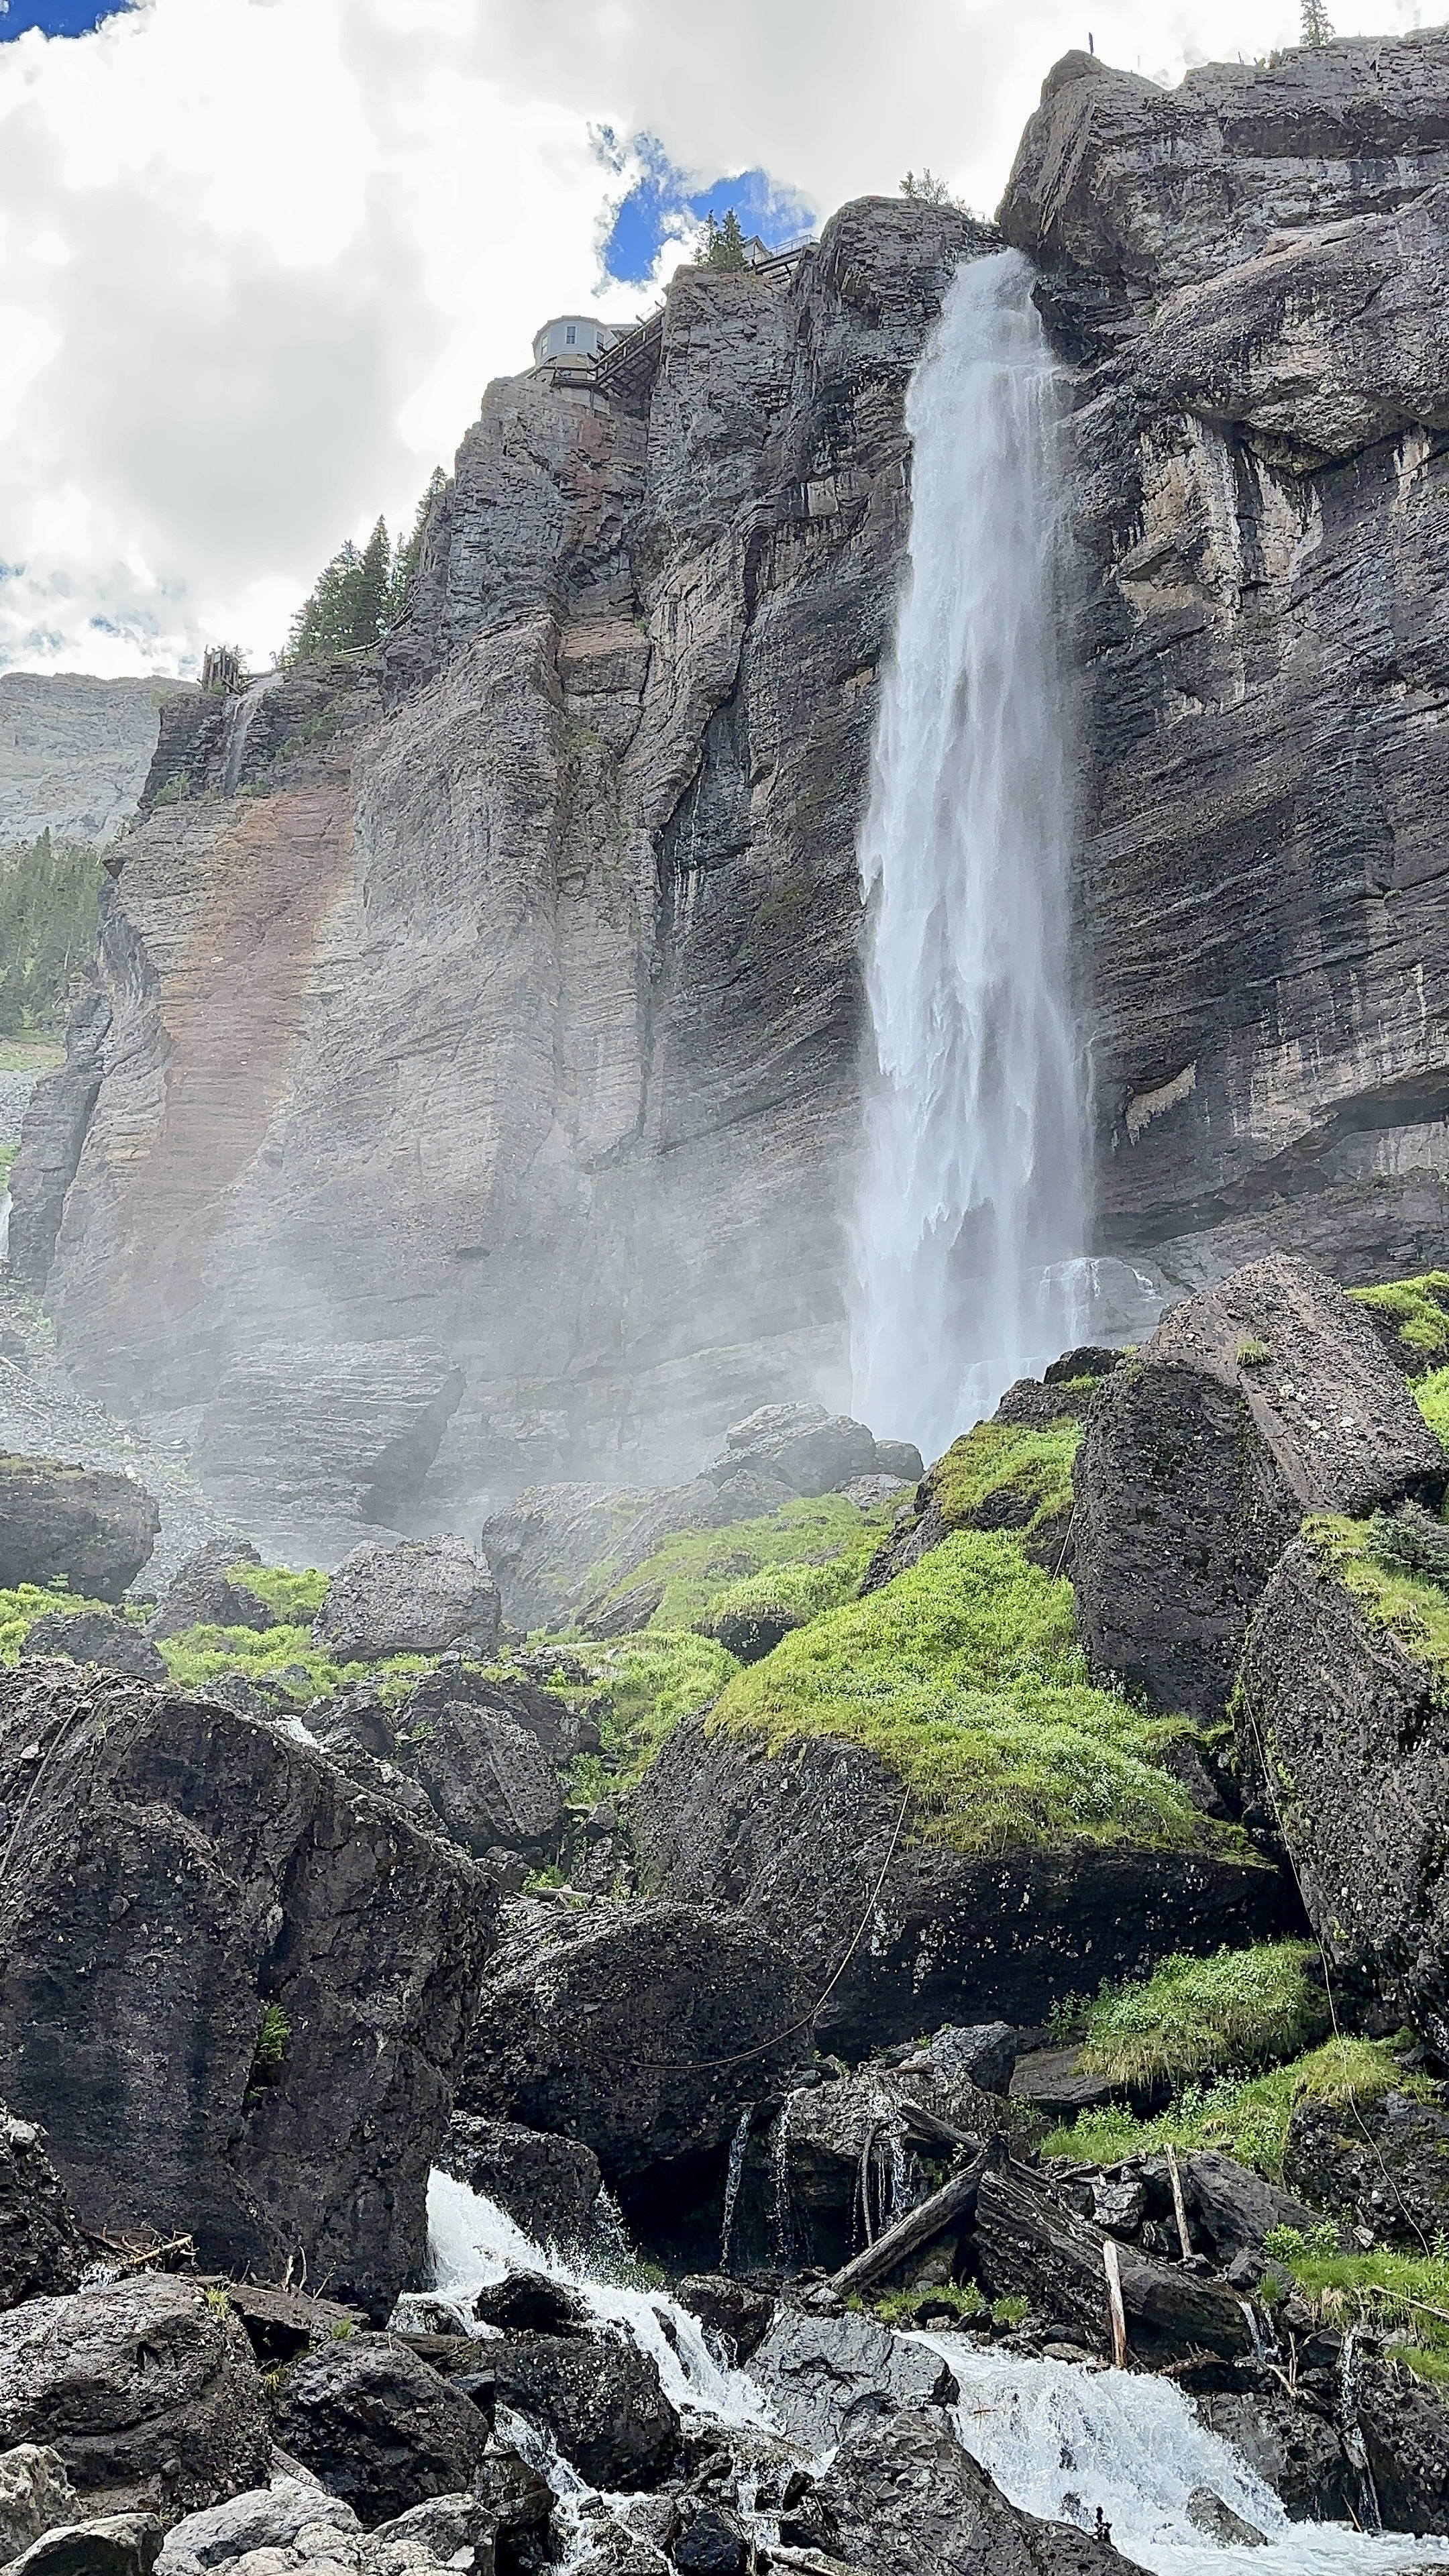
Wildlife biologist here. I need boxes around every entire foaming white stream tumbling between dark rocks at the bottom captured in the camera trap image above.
[405,2171,1449,2576]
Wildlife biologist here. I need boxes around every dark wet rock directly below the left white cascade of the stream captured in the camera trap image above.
[487,2334,681,2491]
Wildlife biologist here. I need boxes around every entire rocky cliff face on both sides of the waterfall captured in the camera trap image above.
[13,36,1449,1536]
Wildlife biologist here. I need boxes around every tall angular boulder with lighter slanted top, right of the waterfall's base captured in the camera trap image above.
[1067,1252,1449,1718]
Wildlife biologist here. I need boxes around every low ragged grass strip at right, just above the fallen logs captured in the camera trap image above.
[1042,2040,1434,2182]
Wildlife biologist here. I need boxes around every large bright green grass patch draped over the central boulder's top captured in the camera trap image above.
[712,1533,1222,1858]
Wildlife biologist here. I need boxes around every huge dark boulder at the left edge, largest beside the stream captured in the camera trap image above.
[0,1664,495,2316]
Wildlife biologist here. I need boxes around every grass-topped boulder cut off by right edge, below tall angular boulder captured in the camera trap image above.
[1235,1525,1449,2053]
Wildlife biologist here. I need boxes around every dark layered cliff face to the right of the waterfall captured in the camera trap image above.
[1000,34,1449,1285]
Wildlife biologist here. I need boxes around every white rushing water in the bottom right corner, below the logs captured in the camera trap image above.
[923,2334,1449,2576]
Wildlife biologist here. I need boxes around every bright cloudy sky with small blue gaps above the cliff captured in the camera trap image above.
[0,0,1436,678]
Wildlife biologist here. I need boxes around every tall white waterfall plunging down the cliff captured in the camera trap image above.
[851,250,1085,1458]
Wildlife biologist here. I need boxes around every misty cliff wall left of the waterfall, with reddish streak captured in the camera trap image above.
[15,201,979,1546]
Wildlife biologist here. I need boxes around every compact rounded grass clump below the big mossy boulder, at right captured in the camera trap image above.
[1067,1940,1330,2084]
